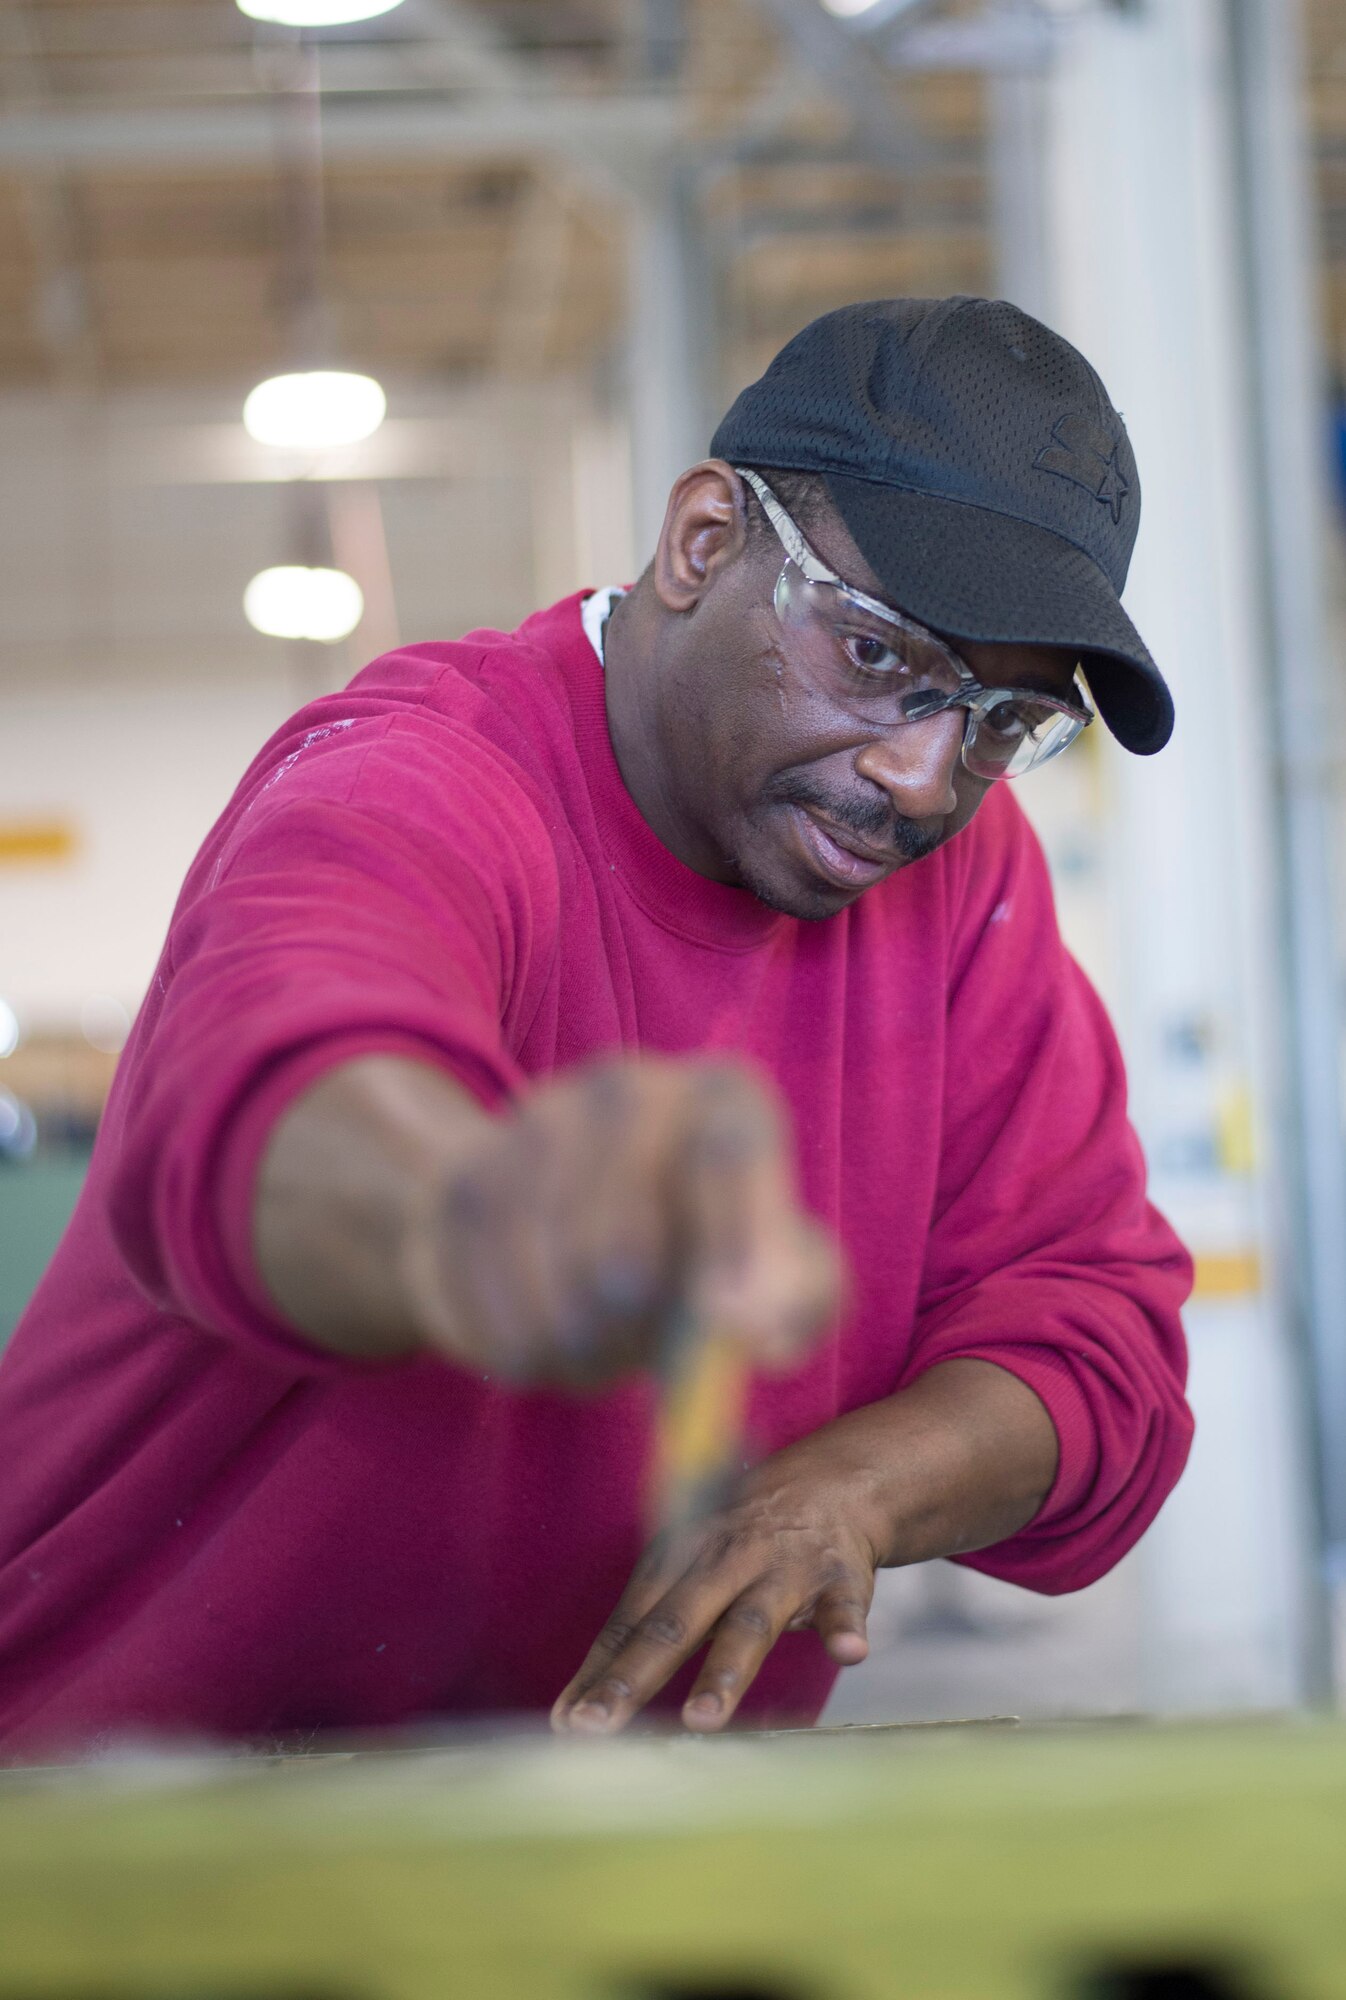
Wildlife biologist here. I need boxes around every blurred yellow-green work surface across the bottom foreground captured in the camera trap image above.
[0,1722,1346,2000]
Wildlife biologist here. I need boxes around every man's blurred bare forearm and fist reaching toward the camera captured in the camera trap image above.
[254,1056,840,1388]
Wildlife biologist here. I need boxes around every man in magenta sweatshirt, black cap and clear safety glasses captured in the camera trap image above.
[0,300,1190,1758]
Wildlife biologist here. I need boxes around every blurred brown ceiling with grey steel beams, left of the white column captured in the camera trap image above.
[0,0,992,388]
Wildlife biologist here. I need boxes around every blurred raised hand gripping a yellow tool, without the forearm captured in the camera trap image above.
[402,1058,840,1386]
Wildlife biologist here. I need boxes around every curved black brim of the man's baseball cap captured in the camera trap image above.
[824,472,1174,756]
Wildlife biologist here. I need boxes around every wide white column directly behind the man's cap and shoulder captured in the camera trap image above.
[1044,0,1312,1708]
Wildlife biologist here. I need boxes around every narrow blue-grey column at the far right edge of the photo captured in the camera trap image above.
[1228,0,1346,1672]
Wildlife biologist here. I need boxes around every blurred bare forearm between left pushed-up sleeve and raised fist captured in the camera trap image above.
[252,1056,488,1358]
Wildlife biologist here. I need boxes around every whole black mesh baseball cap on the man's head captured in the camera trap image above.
[710,298,1174,756]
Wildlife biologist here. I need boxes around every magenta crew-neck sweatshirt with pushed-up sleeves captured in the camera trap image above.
[0,598,1190,1758]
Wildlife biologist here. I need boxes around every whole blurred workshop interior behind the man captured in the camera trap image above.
[0,0,1346,1720]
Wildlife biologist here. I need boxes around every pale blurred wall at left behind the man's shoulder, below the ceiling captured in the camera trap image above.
[0,384,632,1026]
